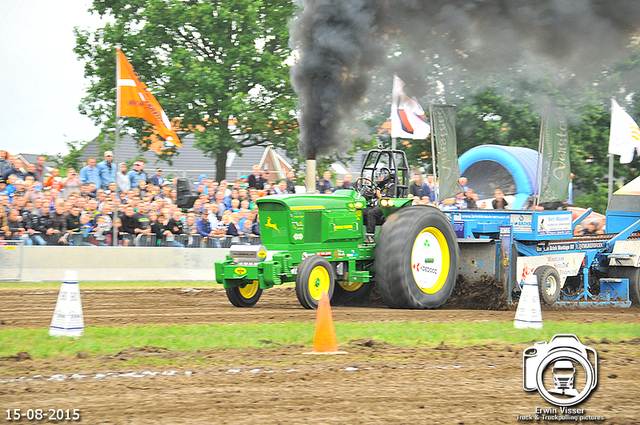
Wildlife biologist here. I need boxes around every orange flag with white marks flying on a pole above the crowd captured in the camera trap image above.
[117,49,182,148]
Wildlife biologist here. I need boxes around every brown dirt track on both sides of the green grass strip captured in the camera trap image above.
[0,288,640,424]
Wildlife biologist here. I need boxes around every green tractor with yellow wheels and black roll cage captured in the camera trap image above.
[215,149,459,309]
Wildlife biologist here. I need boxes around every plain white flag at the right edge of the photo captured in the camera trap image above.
[609,99,640,164]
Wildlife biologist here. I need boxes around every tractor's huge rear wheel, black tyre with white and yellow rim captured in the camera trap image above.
[375,206,460,309]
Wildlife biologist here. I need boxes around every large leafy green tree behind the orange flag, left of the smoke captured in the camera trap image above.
[75,0,297,180]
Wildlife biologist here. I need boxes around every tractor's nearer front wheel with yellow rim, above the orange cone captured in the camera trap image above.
[296,255,336,309]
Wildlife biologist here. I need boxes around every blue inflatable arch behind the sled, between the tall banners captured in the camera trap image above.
[458,145,538,210]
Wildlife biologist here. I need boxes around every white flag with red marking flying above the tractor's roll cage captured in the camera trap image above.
[391,75,431,139]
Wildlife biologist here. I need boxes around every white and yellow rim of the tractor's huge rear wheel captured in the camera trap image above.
[411,227,450,294]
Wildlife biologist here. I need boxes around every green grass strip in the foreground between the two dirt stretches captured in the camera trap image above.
[0,322,640,358]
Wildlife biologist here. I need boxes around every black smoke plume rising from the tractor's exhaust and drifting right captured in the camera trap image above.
[291,0,640,158]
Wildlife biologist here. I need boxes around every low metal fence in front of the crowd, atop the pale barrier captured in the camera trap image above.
[0,232,262,248]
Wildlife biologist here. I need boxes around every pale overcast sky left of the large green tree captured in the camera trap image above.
[0,0,102,154]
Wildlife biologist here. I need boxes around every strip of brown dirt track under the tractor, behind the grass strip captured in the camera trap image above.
[0,287,640,328]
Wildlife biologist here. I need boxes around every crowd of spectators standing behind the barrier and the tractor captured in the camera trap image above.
[0,150,592,247]
